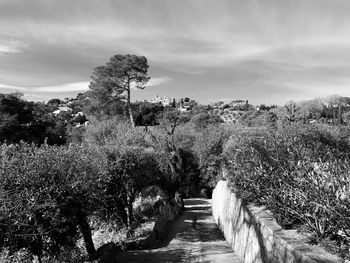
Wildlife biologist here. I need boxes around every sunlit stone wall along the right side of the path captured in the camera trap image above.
[212,181,341,263]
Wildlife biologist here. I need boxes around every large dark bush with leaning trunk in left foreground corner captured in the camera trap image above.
[0,143,106,257]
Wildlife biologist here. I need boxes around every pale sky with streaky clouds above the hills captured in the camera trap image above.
[0,0,350,105]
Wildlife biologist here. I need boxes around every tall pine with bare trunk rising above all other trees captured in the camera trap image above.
[89,54,150,126]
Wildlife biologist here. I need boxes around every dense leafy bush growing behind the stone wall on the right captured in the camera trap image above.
[224,125,350,244]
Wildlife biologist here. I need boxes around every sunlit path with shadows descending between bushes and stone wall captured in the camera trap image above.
[103,199,240,263]
